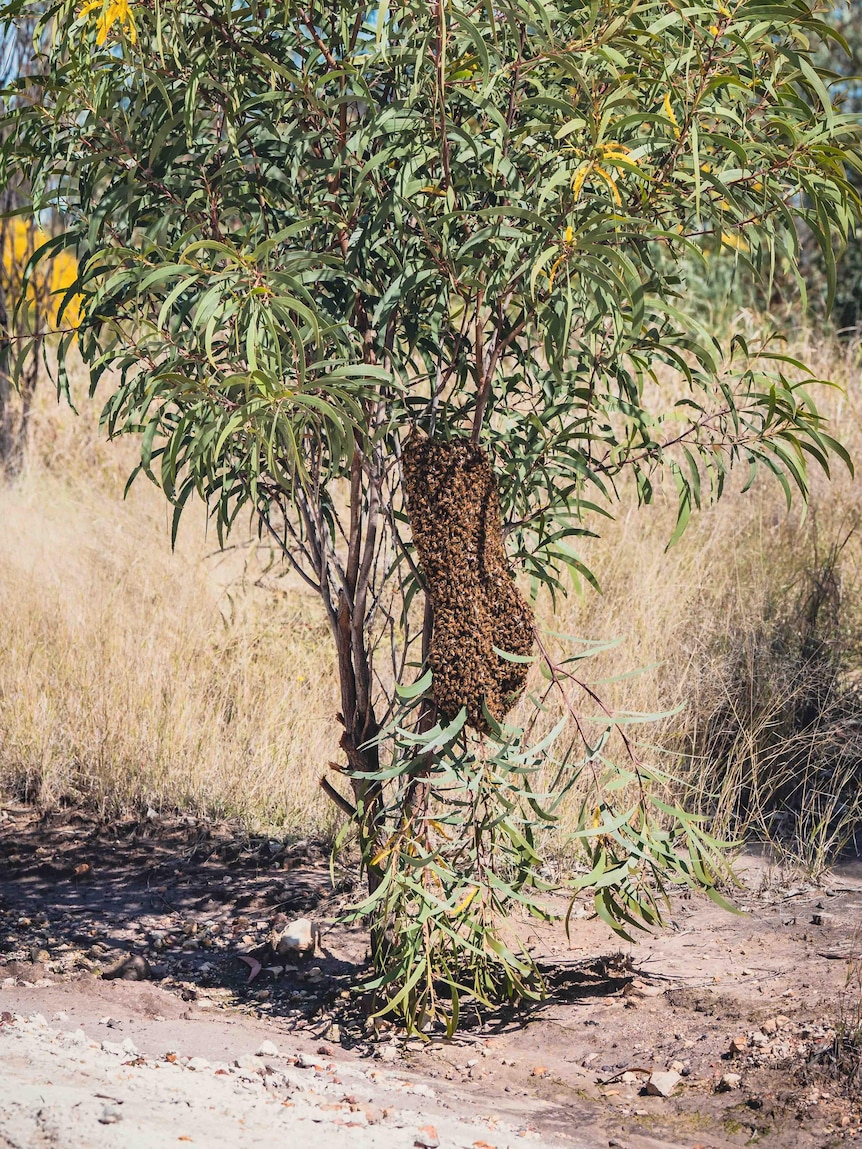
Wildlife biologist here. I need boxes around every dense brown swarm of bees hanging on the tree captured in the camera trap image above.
[402,431,533,733]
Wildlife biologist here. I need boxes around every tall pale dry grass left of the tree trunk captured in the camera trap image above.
[0,390,337,831]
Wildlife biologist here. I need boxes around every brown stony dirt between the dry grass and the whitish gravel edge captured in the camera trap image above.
[0,807,862,1149]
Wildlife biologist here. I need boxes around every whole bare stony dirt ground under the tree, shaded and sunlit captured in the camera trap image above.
[0,807,862,1149]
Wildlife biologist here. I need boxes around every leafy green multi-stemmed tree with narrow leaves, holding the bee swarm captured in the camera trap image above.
[0,0,860,1026]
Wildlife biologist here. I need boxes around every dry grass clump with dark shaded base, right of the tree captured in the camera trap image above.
[547,333,862,871]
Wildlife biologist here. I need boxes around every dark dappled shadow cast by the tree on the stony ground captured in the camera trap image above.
[0,805,648,1044]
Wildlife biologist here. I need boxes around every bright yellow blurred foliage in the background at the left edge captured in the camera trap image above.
[0,216,80,331]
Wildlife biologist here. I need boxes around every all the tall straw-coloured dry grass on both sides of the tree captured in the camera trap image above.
[0,333,862,856]
